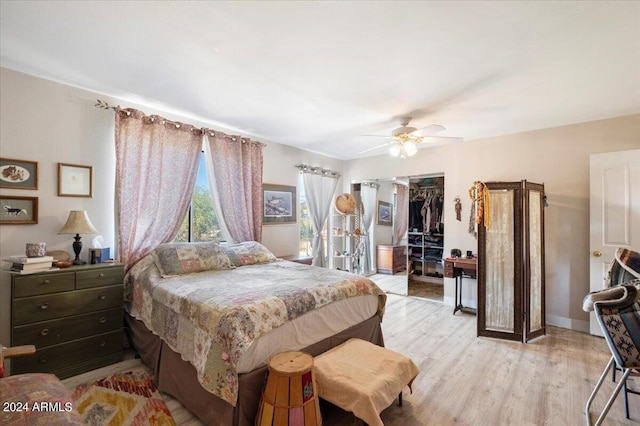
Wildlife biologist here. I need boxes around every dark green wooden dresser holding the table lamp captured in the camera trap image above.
[11,264,124,379]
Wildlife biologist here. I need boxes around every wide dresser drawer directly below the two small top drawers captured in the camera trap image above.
[13,284,123,327]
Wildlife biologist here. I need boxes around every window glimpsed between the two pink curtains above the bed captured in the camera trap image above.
[174,153,222,242]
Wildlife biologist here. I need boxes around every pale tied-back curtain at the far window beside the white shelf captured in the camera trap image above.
[302,172,338,267]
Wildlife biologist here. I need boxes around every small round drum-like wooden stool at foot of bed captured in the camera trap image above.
[256,352,322,426]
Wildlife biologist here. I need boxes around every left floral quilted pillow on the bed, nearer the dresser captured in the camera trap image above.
[151,243,234,277]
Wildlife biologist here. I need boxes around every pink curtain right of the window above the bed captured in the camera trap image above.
[205,132,264,243]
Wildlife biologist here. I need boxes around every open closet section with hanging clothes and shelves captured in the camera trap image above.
[407,176,444,300]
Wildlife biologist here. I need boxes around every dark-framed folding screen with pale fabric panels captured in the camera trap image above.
[474,180,545,342]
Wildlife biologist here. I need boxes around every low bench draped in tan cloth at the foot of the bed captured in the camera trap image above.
[314,339,419,426]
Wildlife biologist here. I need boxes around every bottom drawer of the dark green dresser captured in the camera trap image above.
[11,329,123,374]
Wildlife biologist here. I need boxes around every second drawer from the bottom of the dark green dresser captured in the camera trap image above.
[11,308,123,348]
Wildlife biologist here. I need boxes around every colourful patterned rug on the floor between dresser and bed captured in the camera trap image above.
[72,368,176,426]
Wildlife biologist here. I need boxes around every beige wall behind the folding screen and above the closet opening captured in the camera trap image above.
[343,115,640,331]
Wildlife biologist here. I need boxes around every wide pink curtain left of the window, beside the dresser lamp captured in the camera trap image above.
[115,109,202,269]
